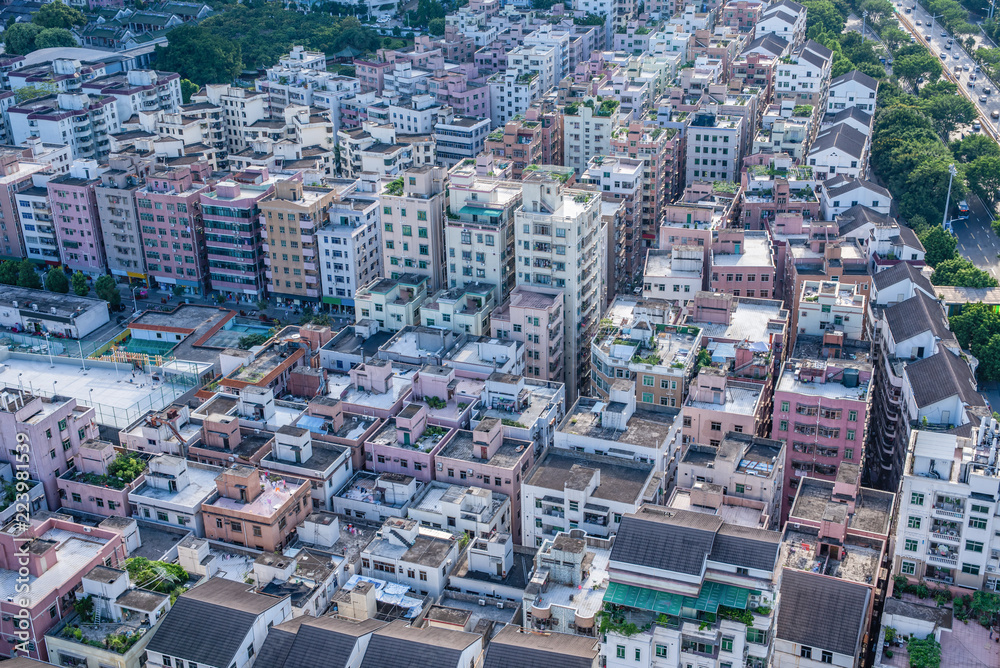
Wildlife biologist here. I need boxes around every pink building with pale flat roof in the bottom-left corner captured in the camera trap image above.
[0,516,128,661]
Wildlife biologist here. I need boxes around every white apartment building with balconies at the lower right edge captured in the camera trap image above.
[893,426,1000,591]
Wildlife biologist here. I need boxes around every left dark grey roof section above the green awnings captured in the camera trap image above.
[611,506,722,575]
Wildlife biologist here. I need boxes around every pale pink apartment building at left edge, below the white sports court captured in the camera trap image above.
[0,383,98,510]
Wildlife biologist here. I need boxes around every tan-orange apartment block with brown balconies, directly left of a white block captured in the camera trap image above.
[260,180,336,305]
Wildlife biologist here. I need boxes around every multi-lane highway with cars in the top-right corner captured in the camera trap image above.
[896,0,1000,142]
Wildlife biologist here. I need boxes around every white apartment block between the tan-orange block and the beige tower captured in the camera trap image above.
[316,192,383,316]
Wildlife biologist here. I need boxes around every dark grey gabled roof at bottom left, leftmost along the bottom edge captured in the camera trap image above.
[147,577,283,666]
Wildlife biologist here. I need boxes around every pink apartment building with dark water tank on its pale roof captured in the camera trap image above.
[771,348,872,523]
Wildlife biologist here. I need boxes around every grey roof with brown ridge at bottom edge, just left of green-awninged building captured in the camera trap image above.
[483,626,601,668]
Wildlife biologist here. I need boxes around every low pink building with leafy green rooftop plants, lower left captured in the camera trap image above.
[56,440,146,517]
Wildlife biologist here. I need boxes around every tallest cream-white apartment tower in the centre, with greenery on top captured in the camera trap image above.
[514,172,610,400]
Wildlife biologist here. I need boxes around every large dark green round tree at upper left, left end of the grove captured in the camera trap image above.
[156,24,243,85]
